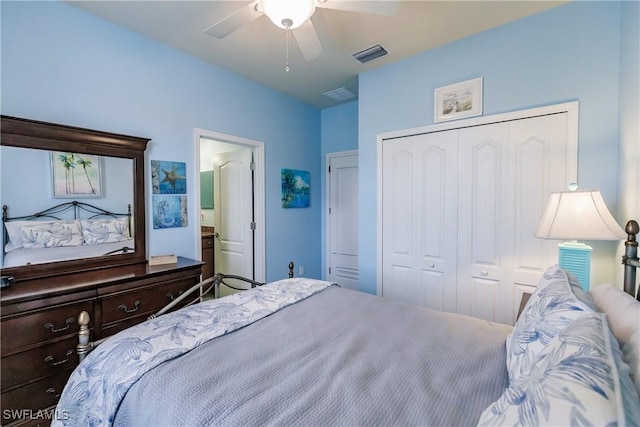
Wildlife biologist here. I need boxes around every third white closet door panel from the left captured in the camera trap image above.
[458,123,510,321]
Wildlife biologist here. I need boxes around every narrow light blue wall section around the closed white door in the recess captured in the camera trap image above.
[320,101,358,279]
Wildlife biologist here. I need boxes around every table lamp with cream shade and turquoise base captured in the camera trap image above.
[534,190,627,291]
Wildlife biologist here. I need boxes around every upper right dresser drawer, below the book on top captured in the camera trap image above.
[102,279,197,329]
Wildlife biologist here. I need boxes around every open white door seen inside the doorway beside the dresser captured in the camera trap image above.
[213,148,254,295]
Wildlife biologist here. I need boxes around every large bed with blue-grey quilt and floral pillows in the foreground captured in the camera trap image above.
[53,222,640,426]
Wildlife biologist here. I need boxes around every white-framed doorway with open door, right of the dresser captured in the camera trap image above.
[195,129,266,294]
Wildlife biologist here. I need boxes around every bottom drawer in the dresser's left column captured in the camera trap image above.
[0,369,73,425]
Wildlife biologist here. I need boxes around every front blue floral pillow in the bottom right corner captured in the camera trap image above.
[478,313,640,426]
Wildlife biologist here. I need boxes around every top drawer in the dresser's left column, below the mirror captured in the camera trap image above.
[0,301,93,356]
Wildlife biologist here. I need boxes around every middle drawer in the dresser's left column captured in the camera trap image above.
[2,336,78,392]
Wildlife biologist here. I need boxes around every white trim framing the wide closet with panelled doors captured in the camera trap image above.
[376,101,580,295]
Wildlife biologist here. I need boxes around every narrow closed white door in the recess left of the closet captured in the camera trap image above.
[328,153,358,290]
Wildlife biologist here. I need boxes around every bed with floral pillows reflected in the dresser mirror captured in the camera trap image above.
[2,200,134,268]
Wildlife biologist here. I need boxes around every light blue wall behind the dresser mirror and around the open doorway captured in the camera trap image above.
[1,1,321,280]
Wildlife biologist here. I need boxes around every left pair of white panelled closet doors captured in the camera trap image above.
[382,130,458,311]
